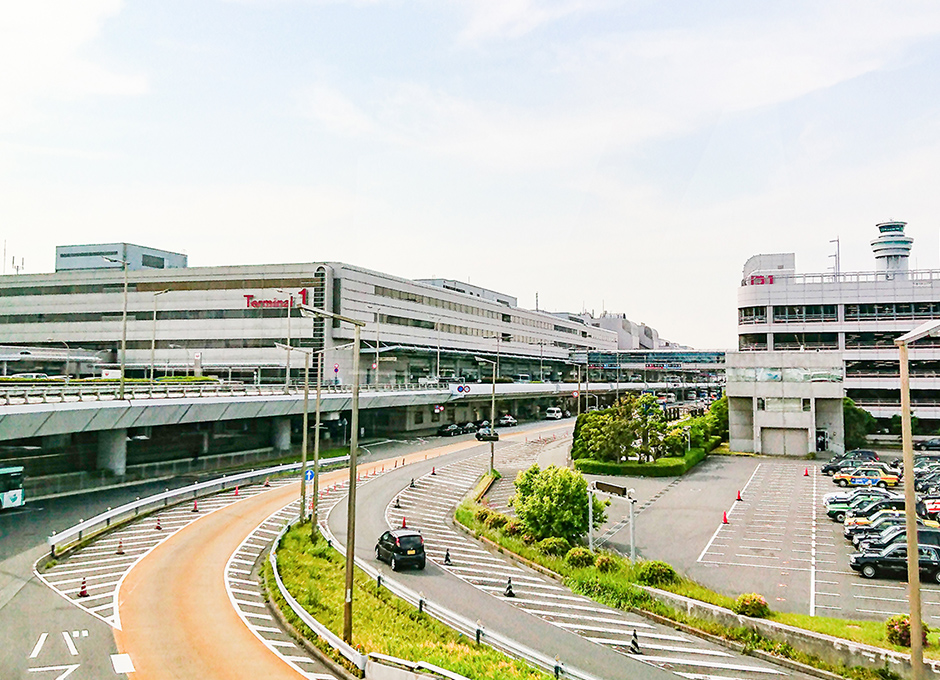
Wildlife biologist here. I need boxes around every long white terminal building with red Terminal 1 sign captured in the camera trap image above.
[0,244,618,383]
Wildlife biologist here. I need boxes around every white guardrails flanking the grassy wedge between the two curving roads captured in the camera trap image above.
[302,523,598,680]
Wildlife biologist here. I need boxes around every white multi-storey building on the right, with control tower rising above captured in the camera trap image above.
[728,221,940,453]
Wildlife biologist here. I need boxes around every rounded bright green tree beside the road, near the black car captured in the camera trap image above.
[512,465,607,542]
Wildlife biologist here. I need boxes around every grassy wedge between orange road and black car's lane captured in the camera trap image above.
[263,524,549,680]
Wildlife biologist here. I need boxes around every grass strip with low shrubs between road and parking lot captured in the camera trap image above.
[455,500,920,680]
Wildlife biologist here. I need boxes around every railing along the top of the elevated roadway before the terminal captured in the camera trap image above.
[0,382,448,406]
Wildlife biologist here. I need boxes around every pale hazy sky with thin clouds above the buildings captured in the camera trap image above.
[0,0,940,348]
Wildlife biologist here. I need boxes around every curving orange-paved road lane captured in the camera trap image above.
[114,431,532,680]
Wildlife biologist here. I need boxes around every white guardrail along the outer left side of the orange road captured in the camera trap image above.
[46,455,349,557]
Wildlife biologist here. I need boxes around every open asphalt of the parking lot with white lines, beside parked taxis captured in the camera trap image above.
[612,457,940,625]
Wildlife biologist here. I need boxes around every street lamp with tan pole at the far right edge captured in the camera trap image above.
[894,320,940,680]
